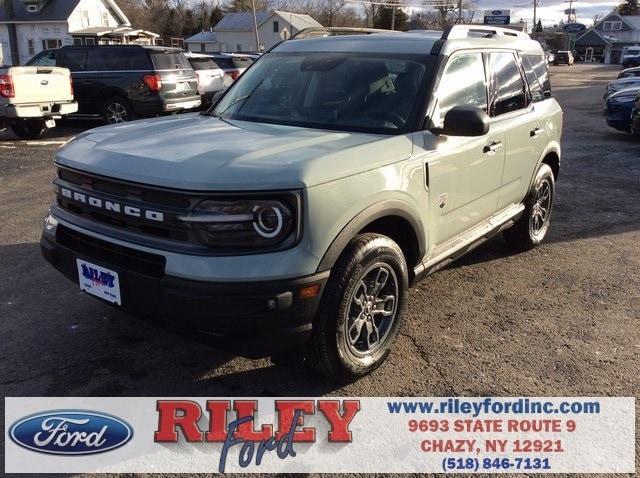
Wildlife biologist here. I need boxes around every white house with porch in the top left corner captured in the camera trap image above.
[0,0,158,65]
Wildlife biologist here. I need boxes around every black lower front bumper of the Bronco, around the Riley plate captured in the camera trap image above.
[40,215,329,344]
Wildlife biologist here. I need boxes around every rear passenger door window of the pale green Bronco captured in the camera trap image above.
[487,51,527,116]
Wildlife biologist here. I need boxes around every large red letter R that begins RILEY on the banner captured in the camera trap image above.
[154,400,203,442]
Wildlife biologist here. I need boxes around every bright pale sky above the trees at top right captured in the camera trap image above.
[474,0,621,25]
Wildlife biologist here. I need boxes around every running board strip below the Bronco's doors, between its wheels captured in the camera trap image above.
[413,203,524,283]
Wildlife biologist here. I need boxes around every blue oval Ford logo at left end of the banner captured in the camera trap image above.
[9,410,133,455]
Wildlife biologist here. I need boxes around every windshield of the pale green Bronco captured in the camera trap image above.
[212,53,428,133]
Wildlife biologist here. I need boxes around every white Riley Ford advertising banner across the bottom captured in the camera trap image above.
[5,397,635,474]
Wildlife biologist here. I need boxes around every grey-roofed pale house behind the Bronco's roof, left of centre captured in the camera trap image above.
[185,10,322,52]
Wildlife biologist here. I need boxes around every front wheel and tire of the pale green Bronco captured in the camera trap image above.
[308,233,409,381]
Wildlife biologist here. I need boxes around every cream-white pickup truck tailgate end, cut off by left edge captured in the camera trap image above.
[0,66,78,139]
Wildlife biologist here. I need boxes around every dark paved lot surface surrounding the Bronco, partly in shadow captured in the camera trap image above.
[0,65,640,478]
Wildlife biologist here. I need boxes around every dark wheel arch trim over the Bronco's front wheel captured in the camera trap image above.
[318,200,426,275]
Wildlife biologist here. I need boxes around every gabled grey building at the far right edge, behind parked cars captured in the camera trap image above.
[575,11,640,65]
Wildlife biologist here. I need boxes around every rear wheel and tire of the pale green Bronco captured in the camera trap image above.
[504,163,556,251]
